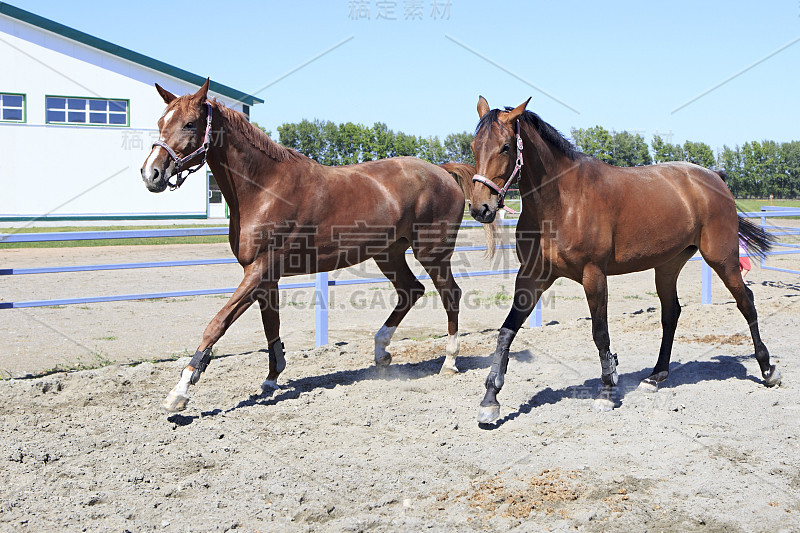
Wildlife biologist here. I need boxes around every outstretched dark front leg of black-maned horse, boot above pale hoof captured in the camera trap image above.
[478,264,555,424]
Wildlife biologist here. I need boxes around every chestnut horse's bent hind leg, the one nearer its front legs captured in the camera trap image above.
[373,239,425,366]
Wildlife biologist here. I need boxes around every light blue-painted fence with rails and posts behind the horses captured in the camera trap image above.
[0,206,800,346]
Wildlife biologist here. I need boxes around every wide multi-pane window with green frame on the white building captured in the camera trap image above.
[45,96,129,126]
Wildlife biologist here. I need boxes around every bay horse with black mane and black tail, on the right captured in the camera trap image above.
[470,97,781,424]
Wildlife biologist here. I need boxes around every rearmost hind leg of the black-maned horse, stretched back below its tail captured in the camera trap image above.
[703,248,781,387]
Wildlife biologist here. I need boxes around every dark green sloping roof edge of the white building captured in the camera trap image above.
[0,2,264,106]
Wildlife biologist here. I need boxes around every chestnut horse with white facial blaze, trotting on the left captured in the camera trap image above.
[141,80,475,411]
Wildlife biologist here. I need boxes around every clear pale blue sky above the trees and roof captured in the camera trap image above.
[11,0,800,150]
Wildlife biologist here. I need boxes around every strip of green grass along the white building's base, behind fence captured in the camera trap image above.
[0,224,228,250]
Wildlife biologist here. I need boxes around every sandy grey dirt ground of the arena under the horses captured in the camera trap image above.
[0,227,800,532]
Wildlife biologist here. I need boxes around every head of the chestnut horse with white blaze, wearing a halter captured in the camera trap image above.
[142,80,210,192]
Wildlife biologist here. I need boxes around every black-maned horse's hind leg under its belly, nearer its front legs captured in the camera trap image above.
[639,247,697,392]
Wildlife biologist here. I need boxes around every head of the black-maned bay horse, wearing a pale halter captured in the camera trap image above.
[470,96,530,224]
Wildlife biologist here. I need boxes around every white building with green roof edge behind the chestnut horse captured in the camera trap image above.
[0,3,263,221]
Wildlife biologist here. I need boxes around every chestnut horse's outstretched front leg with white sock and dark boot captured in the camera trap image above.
[162,263,264,412]
